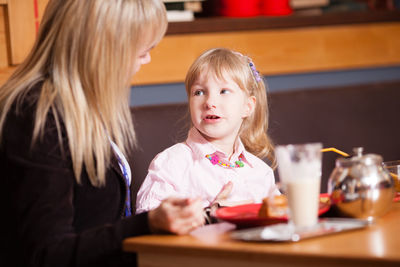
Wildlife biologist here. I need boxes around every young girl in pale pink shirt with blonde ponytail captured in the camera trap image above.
[136,48,275,217]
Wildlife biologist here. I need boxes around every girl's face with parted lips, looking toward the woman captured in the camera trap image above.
[189,69,256,153]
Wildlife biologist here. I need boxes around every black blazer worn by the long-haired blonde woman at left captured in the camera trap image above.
[0,89,149,267]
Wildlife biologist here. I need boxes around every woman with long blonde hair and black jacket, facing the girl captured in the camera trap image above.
[0,0,204,266]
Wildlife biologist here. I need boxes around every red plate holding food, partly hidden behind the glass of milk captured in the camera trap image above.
[215,194,330,228]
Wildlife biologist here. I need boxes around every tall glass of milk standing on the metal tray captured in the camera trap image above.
[275,143,322,229]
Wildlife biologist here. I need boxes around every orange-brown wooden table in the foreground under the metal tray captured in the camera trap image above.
[124,203,400,267]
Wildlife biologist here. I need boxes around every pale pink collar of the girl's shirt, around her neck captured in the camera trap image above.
[186,127,253,168]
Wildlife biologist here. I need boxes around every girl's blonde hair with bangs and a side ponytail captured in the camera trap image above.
[185,48,275,166]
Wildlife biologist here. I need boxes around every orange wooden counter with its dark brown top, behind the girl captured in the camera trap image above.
[133,11,400,84]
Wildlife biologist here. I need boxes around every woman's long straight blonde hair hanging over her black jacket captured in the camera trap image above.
[0,0,167,186]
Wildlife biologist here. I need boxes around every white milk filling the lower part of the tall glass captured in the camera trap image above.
[285,177,321,227]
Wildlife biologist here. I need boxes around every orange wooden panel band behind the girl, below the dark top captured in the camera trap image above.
[134,22,400,84]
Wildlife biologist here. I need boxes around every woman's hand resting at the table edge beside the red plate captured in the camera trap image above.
[148,197,204,235]
